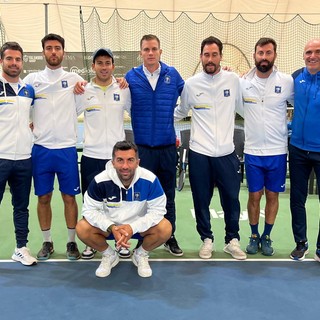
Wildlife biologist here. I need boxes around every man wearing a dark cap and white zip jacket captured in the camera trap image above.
[77,48,131,259]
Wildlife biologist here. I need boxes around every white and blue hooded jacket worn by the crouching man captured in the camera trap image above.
[82,161,166,234]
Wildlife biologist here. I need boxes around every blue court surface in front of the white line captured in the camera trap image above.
[0,259,320,320]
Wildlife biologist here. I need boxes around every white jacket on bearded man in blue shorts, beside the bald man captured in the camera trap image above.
[240,67,294,156]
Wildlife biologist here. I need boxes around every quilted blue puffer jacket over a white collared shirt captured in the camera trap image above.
[126,62,184,147]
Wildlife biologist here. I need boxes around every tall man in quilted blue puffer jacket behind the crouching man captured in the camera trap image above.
[126,34,184,256]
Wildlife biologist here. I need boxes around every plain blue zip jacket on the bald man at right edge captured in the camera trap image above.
[290,68,320,152]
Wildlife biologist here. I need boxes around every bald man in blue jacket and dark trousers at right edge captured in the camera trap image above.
[289,39,320,262]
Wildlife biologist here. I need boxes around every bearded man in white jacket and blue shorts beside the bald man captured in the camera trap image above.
[240,38,293,256]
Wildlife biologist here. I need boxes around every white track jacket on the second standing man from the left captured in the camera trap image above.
[24,67,83,149]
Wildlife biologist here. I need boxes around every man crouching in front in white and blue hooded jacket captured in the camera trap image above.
[76,141,172,277]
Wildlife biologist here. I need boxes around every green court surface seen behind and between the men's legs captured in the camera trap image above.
[0,181,319,260]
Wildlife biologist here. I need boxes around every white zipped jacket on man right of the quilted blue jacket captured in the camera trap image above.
[174,70,242,157]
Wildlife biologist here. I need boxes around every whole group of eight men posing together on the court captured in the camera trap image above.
[0,34,320,277]
